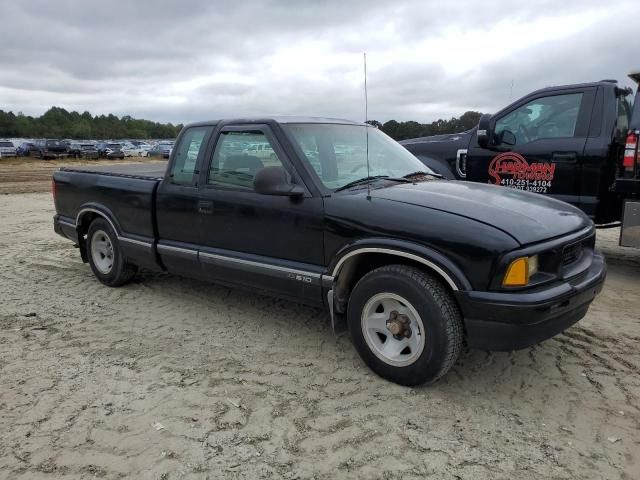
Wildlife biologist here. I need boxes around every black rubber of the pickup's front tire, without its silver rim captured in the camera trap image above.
[347,265,464,386]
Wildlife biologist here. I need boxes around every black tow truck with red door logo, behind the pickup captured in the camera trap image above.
[401,73,640,248]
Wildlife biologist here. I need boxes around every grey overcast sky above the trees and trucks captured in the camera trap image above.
[0,0,640,123]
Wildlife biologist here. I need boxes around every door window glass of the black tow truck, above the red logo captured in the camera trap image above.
[495,93,582,145]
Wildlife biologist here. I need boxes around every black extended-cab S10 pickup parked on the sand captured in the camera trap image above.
[53,118,606,385]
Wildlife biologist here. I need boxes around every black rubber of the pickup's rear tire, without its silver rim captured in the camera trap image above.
[87,218,138,287]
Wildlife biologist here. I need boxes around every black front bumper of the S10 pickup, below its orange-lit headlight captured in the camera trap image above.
[457,252,607,351]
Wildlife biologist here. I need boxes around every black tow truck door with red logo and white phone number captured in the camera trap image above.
[467,87,595,206]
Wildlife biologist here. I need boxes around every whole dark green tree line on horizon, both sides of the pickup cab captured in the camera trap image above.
[0,107,481,140]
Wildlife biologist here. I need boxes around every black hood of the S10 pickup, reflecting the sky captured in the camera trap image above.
[371,180,592,245]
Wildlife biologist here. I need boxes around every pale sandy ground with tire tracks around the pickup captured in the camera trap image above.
[0,189,640,480]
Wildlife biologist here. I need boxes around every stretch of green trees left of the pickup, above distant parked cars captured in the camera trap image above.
[0,107,182,140]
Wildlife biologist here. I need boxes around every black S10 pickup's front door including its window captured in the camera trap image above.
[199,124,324,303]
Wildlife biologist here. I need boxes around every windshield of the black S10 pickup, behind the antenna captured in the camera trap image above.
[283,123,433,190]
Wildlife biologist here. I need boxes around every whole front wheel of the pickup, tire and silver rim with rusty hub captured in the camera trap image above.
[347,265,463,386]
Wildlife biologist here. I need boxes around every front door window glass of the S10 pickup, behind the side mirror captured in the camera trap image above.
[208,131,283,189]
